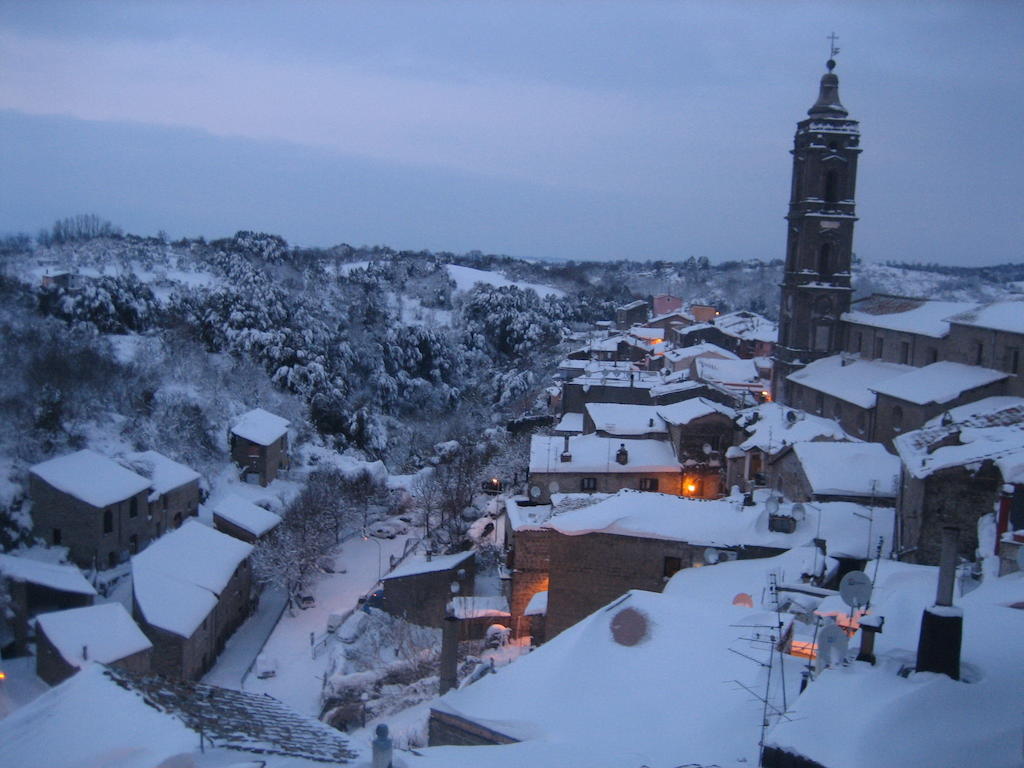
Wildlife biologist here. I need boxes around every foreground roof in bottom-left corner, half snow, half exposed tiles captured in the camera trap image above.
[0,664,355,768]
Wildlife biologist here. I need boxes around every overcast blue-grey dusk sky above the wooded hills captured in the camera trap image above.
[0,0,1024,264]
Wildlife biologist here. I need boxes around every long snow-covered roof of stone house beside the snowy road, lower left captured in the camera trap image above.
[131,520,253,637]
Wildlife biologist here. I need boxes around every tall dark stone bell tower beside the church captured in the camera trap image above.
[772,59,860,403]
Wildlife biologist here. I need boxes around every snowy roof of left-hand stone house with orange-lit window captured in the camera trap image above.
[29,449,150,508]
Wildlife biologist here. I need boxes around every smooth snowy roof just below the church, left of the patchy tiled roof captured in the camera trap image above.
[793,442,900,499]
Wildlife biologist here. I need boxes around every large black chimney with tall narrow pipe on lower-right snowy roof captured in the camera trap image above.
[916,527,964,680]
